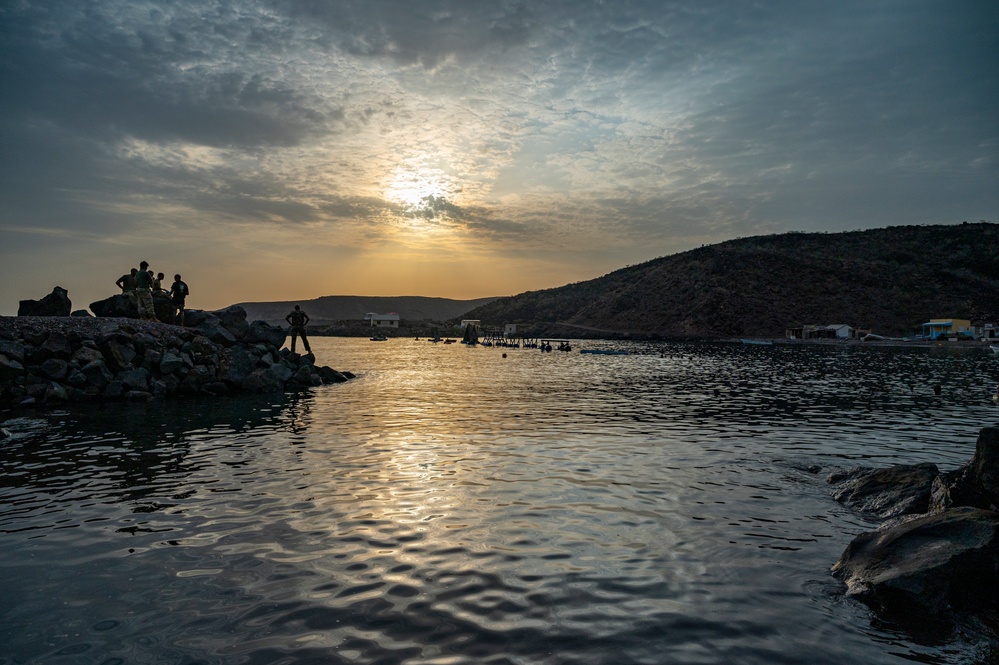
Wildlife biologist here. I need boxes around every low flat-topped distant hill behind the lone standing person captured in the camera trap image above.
[238,296,504,325]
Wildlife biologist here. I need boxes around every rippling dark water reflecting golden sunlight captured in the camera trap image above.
[0,338,999,665]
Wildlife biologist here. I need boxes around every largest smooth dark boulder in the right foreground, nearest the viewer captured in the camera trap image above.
[833,507,999,623]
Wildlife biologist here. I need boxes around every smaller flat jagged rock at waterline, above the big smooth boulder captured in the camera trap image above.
[830,464,940,519]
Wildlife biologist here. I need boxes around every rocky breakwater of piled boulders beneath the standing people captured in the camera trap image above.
[0,307,353,406]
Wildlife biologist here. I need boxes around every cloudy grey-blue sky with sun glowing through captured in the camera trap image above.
[0,0,999,314]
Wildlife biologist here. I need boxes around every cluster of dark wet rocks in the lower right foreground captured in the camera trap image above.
[827,427,999,633]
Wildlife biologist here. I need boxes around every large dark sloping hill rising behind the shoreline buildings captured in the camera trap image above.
[465,223,999,337]
